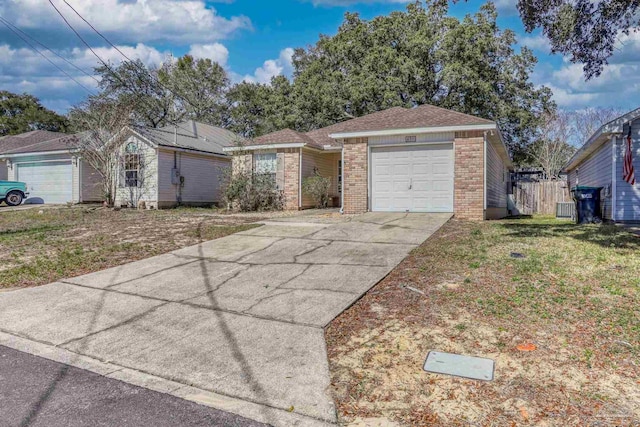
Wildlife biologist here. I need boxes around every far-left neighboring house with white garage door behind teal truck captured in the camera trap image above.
[0,130,102,204]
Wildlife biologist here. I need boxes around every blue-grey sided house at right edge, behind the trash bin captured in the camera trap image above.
[564,108,640,222]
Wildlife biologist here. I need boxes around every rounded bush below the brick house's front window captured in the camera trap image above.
[222,171,284,212]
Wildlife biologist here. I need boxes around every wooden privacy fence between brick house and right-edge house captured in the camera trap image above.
[512,181,572,215]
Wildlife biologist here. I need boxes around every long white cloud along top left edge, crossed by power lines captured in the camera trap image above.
[0,0,251,44]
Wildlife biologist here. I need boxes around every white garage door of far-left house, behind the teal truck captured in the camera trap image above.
[18,161,73,203]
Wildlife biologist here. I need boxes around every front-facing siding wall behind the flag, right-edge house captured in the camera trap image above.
[616,121,640,221]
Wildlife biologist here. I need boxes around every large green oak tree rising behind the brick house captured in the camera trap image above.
[231,2,555,161]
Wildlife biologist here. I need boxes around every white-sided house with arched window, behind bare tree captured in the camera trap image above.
[115,121,241,209]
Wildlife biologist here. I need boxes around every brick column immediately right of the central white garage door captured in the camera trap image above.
[454,133,484,221]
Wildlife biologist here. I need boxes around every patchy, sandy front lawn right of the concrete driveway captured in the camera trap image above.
[326,218,640,426]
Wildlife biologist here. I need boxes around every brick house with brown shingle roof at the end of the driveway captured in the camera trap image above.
[225,105,512,220]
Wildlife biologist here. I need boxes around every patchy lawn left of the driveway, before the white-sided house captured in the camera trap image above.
[0,207,256,289]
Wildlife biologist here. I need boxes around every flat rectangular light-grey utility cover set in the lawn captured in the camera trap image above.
[424,351,495,381]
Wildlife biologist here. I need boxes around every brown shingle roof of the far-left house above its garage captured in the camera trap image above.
[0,130,78,155]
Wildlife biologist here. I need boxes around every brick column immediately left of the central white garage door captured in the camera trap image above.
[342,138,369,214]
